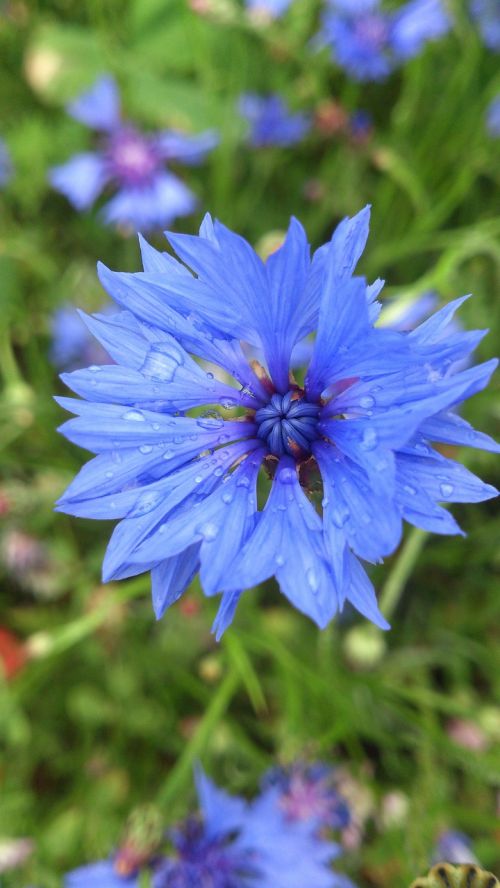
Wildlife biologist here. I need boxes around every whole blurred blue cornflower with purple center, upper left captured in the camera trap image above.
[50,77,217,230]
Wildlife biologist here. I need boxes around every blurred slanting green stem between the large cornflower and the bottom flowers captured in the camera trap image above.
[156,665,241,807]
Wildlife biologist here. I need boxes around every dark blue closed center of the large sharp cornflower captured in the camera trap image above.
[255,392,319,459]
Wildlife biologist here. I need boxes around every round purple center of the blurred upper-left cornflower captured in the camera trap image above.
[107,127,160,186]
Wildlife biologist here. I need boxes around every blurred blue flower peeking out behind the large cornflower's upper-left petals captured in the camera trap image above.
[50,303,114,370]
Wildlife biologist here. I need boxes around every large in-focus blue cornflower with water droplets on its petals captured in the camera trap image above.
[58,207,500,636]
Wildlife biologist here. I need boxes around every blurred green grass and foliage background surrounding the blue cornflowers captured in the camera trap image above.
[0,0,500,888]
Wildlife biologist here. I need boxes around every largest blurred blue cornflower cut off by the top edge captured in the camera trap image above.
[319,0,450,80]
